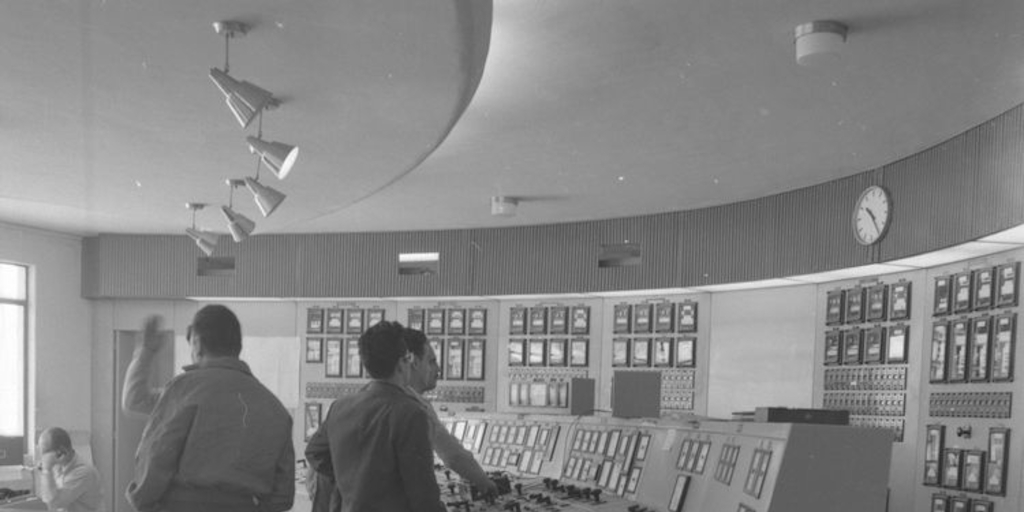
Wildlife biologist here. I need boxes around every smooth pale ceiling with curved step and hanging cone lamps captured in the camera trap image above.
[0,0,1024,234]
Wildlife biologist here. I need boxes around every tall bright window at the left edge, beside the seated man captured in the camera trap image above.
[0,263,28,465]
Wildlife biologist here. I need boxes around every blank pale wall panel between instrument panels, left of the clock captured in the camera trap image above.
[708,285,817,418]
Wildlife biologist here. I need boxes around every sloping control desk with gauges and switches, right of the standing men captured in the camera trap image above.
[438,413,893,512]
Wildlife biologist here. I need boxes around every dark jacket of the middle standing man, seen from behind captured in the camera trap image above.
[319,381,444,512]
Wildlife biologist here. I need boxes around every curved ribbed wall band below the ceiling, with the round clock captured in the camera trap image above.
[82,106,1024,298]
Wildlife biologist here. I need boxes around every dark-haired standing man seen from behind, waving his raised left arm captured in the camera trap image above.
[122,304,295,512]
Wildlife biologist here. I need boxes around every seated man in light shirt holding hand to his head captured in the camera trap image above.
[37,427,102,512]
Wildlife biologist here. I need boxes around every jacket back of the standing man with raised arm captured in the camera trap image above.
[128,358,295,511]
